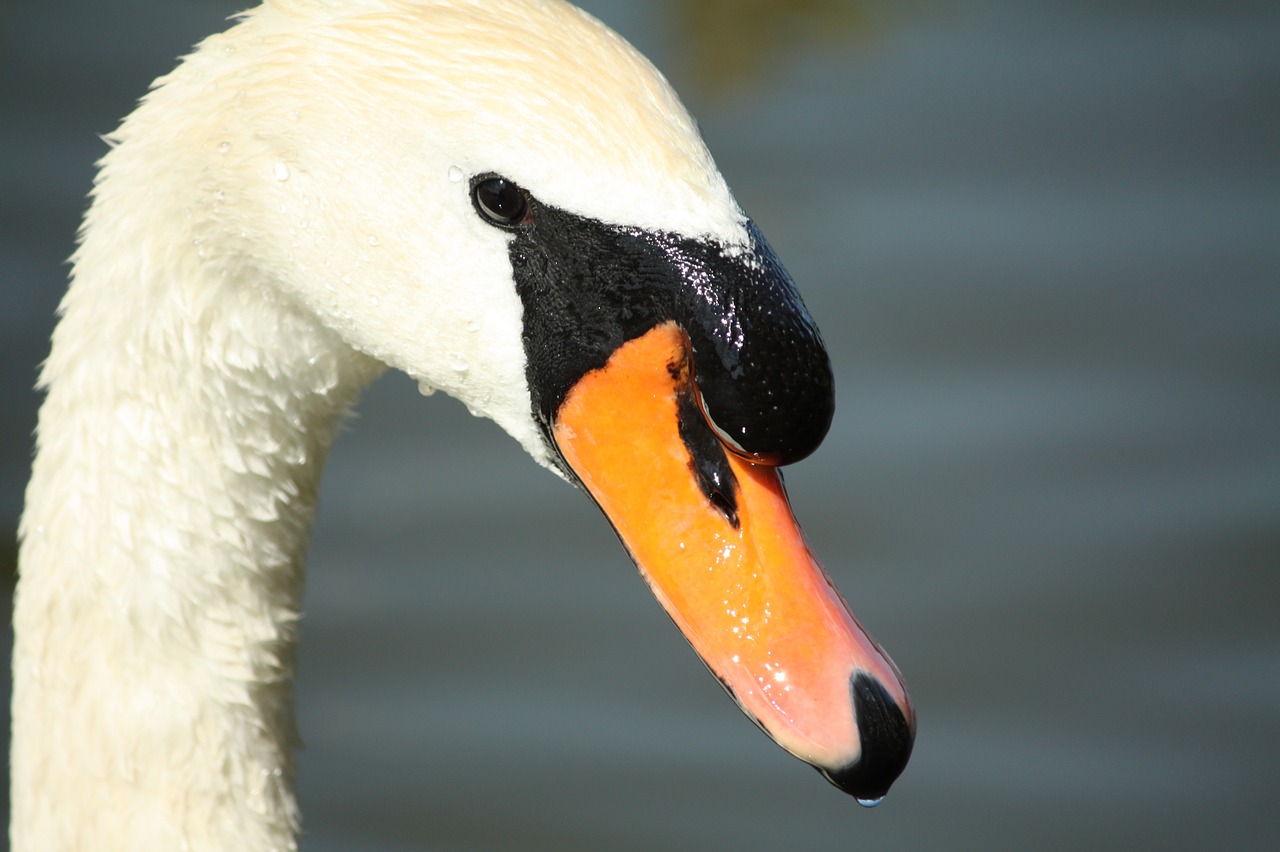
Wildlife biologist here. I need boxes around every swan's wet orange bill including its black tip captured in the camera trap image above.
[552,322,915,805]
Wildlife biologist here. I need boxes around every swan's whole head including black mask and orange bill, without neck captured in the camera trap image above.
[127,0,914,800]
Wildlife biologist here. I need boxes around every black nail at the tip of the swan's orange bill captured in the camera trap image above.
[818,673,915,806]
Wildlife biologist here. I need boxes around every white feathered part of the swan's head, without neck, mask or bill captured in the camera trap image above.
[188,3,749,463]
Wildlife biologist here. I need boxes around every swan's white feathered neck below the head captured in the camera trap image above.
[10,182,380,849]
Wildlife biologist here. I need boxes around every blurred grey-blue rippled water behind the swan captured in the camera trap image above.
[0,0,1280,852]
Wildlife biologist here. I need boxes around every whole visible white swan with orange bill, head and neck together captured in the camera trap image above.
[10,0,915,852]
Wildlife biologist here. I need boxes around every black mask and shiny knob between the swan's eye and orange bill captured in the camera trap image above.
[471,174,835,464]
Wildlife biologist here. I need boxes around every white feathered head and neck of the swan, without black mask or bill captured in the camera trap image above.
[12,0,745,852]
